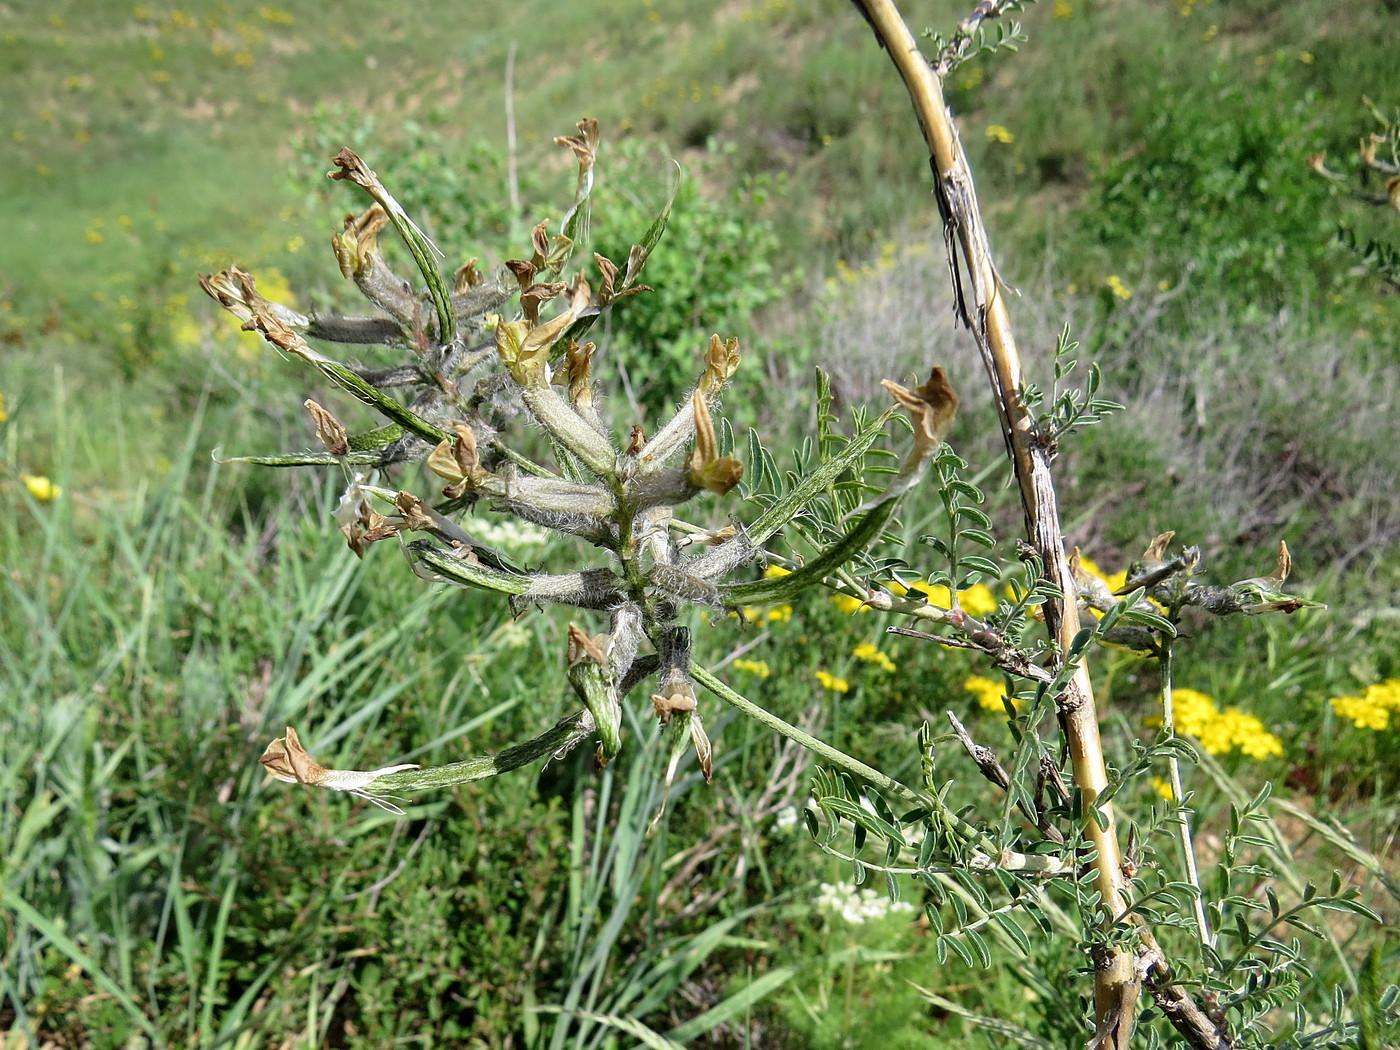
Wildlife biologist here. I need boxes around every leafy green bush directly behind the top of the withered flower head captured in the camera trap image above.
[298,105,805,409]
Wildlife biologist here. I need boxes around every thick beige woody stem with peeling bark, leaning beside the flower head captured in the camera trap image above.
[855,0,1141,1050]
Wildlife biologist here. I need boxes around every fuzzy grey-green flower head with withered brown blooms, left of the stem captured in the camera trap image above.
[202,120,956,808]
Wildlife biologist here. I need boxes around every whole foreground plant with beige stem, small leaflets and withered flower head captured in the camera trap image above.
[203,88,1352,1050]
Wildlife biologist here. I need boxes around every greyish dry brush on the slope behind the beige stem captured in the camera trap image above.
[815,231,1400,588]
